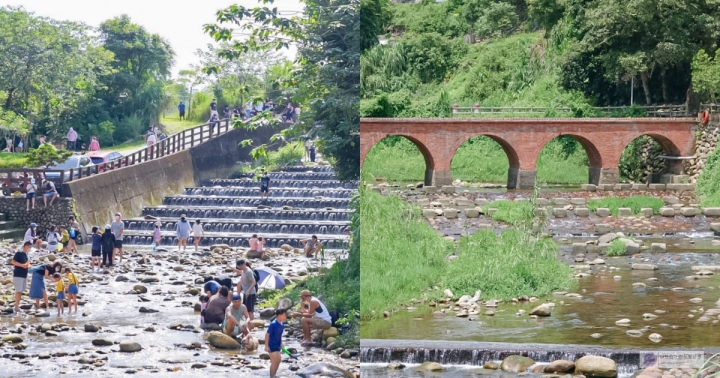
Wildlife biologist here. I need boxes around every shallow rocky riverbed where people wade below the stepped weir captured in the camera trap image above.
[0,244,359,377]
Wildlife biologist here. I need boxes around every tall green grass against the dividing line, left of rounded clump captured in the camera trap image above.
[360,188,452,318]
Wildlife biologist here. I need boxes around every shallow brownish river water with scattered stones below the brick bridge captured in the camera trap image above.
[361,188,720,377]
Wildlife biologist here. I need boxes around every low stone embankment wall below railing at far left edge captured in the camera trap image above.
[0,197,73,235]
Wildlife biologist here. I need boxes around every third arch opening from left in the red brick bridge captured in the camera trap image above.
[535,135,602,185]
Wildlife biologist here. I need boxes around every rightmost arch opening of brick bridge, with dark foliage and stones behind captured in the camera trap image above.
[618,134,684,183]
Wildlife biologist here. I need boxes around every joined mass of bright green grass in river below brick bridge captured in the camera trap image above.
[360,185,574,319]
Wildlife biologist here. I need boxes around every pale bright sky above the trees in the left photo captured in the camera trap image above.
[0,0,303,77]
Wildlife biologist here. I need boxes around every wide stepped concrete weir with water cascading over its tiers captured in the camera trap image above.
[125,167,358,249]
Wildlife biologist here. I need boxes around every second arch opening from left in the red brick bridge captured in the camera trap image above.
[450,135,520,184]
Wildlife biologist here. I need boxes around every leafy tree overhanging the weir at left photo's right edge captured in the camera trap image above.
[205,0,360,180]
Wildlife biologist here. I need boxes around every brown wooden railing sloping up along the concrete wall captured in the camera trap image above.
[0,118,232,195]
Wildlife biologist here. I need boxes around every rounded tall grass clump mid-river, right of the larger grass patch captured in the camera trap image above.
[448,229,575,301]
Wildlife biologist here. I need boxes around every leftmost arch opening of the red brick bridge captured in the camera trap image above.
[363,135,434,185]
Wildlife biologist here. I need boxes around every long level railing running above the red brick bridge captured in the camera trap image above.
[452,104,692,117]
